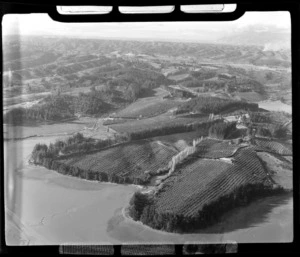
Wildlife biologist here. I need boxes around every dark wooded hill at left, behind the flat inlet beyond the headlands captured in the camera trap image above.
[4,63,175,124]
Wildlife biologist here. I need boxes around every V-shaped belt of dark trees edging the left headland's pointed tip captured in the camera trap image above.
[30,133,151,185]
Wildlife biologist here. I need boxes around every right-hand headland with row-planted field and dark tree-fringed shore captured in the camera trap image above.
[130,146,290,233]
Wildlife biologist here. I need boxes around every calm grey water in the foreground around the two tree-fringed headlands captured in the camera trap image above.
[4,136,293,245]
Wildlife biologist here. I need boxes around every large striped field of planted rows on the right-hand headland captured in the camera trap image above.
[155,149,268,217]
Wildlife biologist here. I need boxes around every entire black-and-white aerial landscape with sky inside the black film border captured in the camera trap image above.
[2,12,293,245]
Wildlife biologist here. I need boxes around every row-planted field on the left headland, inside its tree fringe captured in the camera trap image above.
[58,140,176,183]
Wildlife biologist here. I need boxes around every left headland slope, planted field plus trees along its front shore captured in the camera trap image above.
[33,137,177,185]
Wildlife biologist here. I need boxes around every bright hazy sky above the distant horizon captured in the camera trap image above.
[2,12,290,41]
